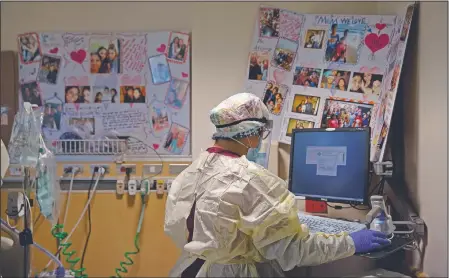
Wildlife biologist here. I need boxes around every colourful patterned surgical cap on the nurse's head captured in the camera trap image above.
[210,93,270,139]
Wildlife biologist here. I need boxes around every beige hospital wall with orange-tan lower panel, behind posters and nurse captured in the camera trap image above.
[1,2,447,277]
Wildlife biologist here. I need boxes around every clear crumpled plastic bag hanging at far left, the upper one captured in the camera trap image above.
[8,102,43,168]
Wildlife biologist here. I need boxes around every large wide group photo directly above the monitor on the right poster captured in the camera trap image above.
[321,99,373,128]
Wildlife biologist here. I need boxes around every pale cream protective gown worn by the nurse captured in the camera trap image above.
[165,152,355,277]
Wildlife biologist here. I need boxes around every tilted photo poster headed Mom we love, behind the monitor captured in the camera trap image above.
[245,5,414,161]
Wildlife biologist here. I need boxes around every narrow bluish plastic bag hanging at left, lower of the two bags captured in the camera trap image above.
[36,136,61,225]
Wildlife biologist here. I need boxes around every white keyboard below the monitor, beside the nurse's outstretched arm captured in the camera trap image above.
[298,213,366,234]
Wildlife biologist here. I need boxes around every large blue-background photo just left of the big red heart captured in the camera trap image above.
[324,24,366,64]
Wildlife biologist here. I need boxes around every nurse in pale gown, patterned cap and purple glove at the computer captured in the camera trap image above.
[164,93,390,277]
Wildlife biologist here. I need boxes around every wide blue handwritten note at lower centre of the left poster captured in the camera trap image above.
[103,110,146,131]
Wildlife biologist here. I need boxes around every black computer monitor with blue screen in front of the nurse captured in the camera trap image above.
[288,128,370,204]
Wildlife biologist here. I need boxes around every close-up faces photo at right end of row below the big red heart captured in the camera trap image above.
[349,72,383,96]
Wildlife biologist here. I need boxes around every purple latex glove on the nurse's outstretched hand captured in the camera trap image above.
[349,230,391,253]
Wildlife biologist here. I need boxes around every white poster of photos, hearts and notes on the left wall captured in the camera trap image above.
[17,32,191,156]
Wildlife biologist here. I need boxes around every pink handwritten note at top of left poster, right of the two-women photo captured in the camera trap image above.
[121,36,147,73]
